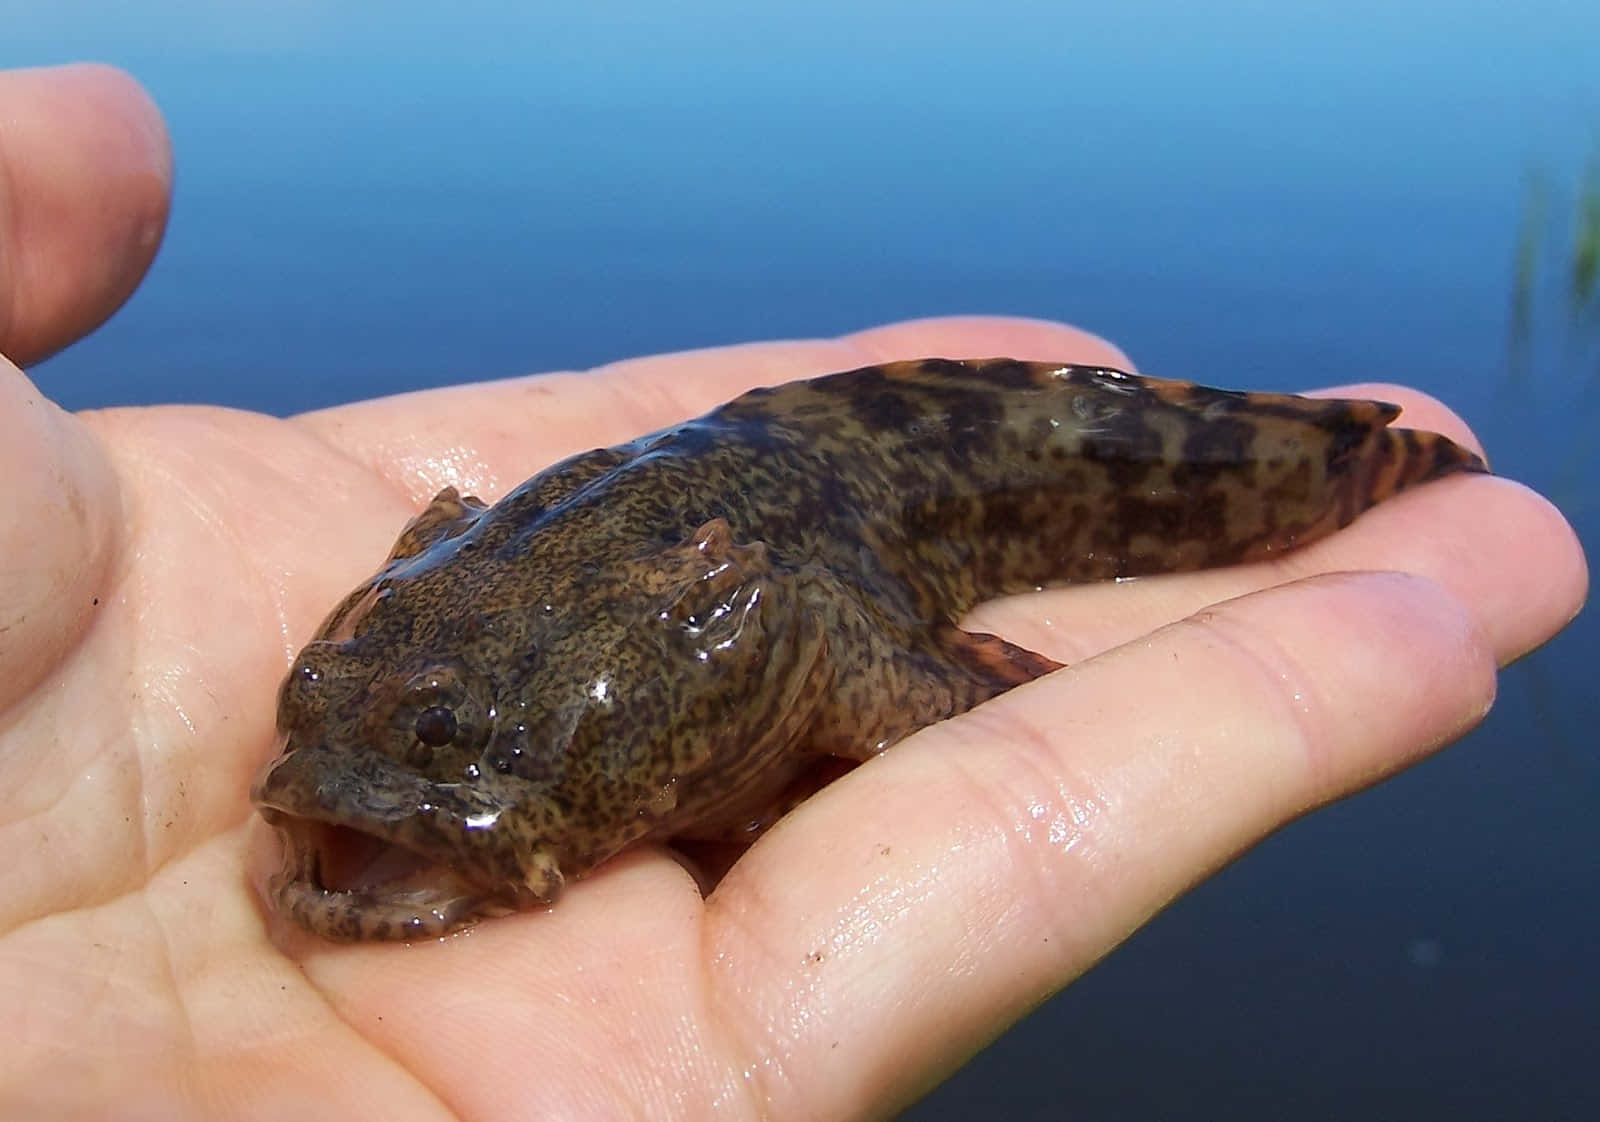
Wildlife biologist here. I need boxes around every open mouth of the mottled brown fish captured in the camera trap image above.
[262,808,517,943]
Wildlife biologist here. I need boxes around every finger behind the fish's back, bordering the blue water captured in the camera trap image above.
[299,317,1128,504]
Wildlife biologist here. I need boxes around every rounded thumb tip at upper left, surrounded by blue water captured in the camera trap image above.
[0,64,173,365]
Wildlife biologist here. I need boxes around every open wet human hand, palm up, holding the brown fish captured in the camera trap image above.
[0,67,1587,1120]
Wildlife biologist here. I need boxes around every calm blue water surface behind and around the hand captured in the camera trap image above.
[0,0,1600,1122]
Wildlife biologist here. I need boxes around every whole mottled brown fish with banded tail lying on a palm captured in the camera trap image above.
[251,359,1488,941]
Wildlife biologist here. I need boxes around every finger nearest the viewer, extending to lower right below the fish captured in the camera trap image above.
[706,575,1494,1117]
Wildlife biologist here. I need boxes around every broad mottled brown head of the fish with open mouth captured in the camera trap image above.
[251,508,826,940]
